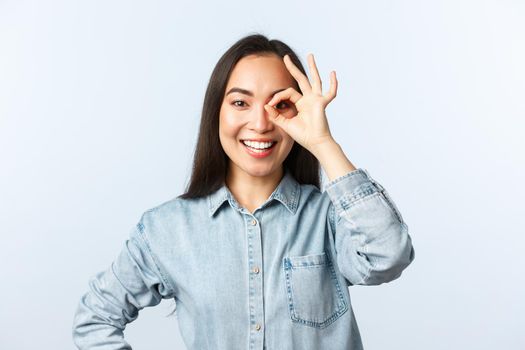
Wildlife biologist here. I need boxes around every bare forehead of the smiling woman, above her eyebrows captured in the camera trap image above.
[226,55,295,94]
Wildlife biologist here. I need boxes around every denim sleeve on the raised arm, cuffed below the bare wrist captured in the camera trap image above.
[325,168,415,285]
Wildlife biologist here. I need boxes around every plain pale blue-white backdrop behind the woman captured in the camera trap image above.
[0,0,525,350]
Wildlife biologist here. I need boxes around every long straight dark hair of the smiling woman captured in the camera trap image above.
[178,34,320,199]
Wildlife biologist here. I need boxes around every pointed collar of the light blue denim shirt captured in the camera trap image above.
[208,168,301,216]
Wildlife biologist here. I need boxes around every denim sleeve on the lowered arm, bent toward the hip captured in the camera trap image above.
[72,211,173,350]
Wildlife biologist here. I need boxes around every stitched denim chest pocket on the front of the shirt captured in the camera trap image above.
[283,252,348,328]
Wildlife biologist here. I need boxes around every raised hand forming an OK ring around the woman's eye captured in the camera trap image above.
[264,54,337,153]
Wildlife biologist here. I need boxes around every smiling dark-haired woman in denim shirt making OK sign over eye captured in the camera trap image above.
[73,35,414,350]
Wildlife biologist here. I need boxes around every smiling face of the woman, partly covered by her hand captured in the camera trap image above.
[219,55,297,180]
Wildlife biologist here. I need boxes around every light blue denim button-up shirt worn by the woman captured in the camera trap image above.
[73,168,414,350]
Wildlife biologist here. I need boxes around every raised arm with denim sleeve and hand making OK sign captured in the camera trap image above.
[265,54,414,284]
